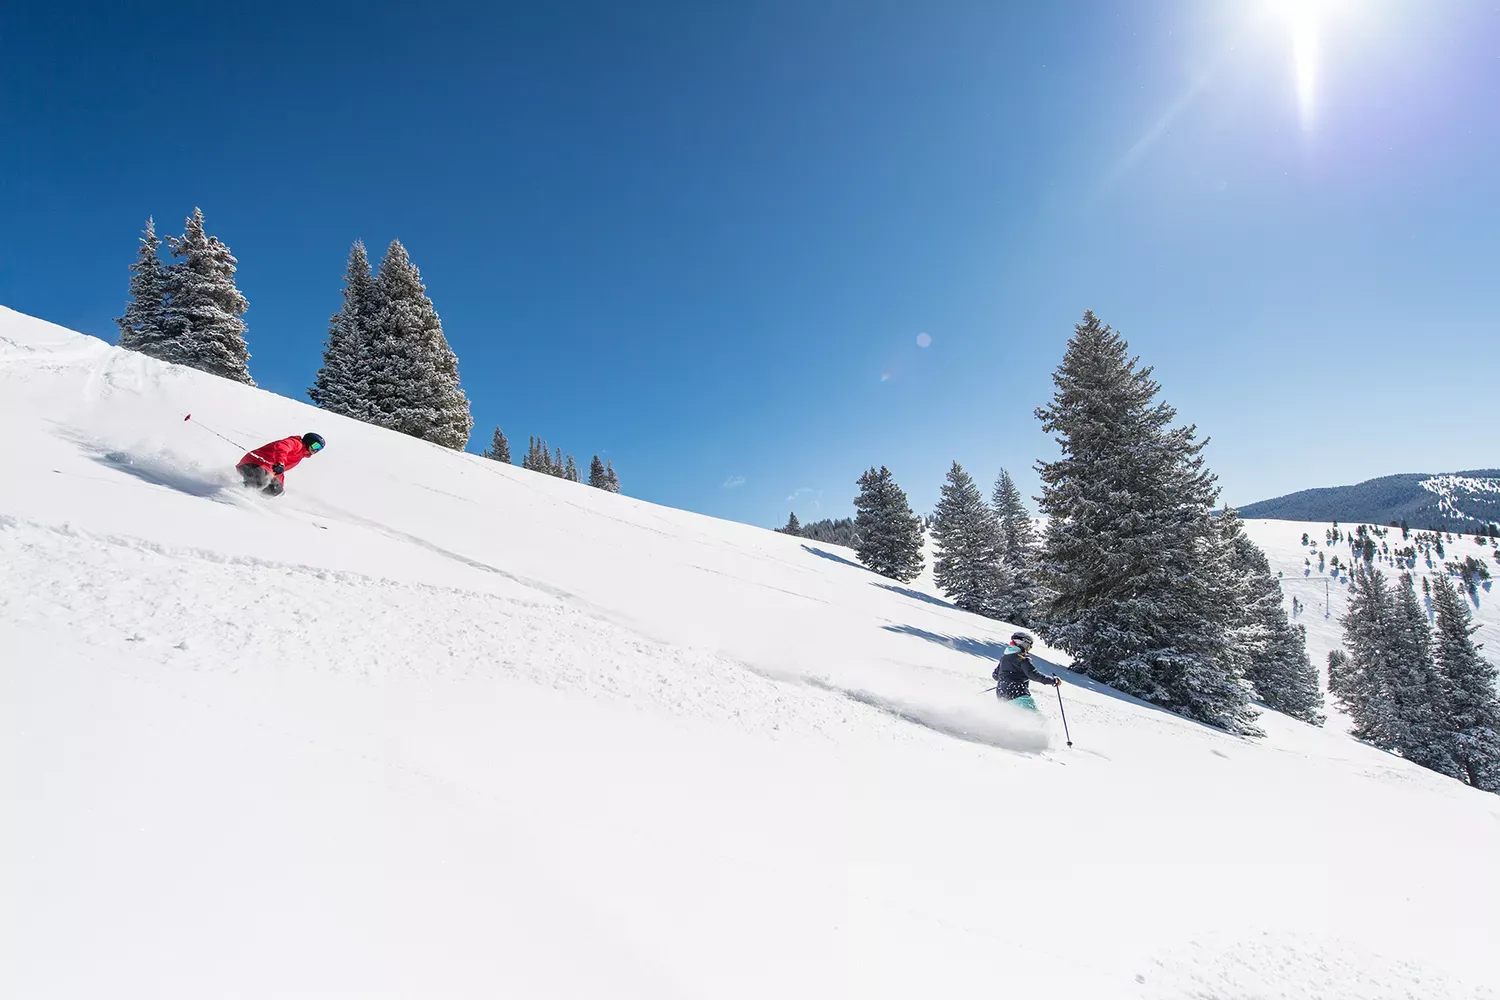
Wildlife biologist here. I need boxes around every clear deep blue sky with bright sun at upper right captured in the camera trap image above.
[0,0,1500,525]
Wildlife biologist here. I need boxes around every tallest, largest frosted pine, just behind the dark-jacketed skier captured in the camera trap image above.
[1037,312,1259,733]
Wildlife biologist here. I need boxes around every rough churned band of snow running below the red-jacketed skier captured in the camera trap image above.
[0,517,848,735]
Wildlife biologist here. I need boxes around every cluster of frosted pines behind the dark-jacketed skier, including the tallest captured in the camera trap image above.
[810,312,1325,735]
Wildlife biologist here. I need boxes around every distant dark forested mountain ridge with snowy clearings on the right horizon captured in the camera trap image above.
[1239,469,1500,532]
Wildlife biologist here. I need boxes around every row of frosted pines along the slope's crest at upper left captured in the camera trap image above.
[116,208,620,493]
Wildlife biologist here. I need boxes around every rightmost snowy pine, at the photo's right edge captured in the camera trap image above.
[1433,576,1500,793]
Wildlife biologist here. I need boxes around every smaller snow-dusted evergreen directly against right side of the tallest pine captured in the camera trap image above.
[1220,508,1328,726]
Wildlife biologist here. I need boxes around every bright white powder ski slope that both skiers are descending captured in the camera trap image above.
[0,310,1500,1000]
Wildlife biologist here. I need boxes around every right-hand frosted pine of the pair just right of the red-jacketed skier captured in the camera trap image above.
[369,240,474,450]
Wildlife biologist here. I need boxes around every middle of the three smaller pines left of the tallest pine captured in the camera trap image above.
[932,462,1001,615]
